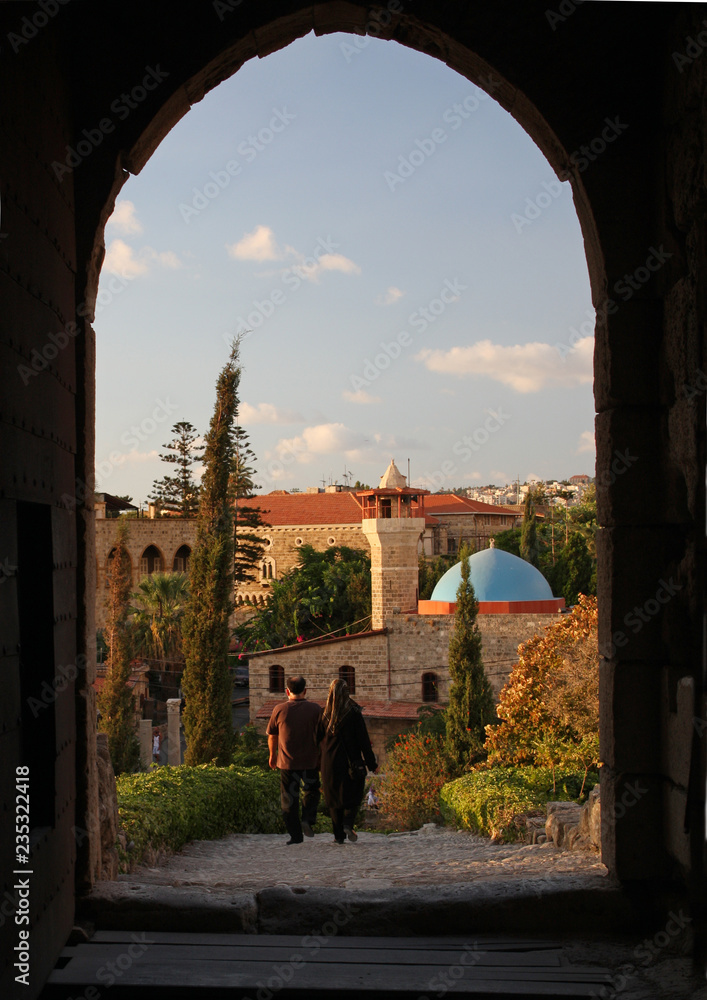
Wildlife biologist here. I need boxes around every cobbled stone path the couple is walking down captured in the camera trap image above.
[120,824,606,894]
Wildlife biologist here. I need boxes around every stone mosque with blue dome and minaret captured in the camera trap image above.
[249,462,564,758]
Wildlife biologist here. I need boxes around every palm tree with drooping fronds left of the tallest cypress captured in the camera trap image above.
[130,573,189,660]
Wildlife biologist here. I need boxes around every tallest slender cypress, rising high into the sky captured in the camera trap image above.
[182,340,241,764]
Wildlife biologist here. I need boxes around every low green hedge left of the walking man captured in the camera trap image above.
[117,764,285,868]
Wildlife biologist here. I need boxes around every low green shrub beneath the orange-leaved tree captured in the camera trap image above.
[439,767,592,841]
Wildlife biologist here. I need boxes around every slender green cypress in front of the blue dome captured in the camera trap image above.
[447,556,496,767]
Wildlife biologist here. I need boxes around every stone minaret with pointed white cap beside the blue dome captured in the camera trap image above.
[359,459,429,628]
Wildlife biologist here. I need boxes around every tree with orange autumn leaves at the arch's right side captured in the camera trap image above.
[485,595,599,777]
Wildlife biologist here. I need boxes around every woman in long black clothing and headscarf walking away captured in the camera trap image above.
[317,680,378,844]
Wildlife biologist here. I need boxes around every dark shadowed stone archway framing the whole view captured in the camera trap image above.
[0,0,707,996]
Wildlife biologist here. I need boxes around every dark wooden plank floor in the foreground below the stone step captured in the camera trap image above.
[41,931,611,1000]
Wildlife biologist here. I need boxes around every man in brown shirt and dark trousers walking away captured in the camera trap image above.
[266,677,322,845]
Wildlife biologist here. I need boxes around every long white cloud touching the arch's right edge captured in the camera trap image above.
[415,337,594,393]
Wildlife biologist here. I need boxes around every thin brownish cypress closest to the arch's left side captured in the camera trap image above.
[98,524,140,774]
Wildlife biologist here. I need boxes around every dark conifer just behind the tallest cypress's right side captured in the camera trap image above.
[230,424,268,585]
